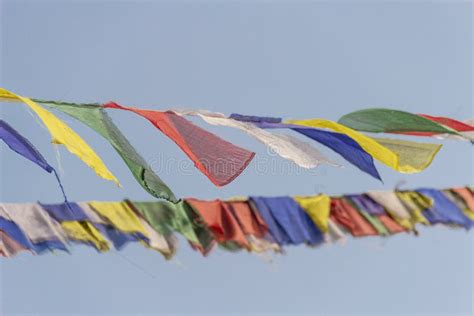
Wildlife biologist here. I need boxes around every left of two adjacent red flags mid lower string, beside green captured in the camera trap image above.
[186,199,250,250]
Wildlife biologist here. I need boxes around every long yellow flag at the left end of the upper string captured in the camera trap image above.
[0,88,120,185]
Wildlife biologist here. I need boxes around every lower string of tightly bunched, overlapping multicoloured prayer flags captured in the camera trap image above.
[0,187,474,259]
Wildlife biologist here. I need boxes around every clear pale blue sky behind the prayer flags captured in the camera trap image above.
[0,0,474,316]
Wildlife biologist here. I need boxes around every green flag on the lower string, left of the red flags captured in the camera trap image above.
[129,201,213,254]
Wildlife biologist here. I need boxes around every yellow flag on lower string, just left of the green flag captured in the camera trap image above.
[89,201,148,239]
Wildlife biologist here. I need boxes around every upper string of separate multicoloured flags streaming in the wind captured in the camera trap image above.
[0,88,474,202]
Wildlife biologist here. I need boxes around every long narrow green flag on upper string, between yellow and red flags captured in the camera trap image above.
[39,100,177,203]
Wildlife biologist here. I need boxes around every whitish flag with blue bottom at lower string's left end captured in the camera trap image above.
[0,203,67,253]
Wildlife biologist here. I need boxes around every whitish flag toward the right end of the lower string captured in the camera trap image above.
[367,191,413,229]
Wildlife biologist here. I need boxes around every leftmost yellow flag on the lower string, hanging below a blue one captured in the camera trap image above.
[61,221,110,252]
